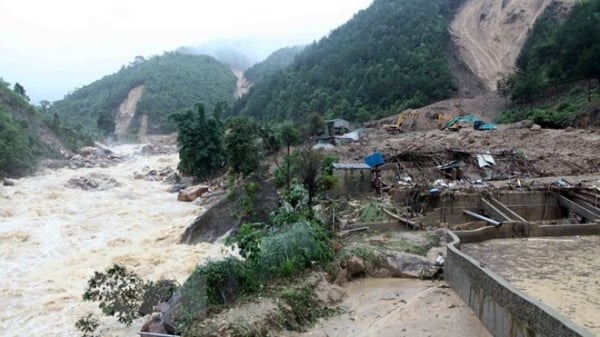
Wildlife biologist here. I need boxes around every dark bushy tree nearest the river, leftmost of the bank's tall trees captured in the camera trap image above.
[169,103,224,181]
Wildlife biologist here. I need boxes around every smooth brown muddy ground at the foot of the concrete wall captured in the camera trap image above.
[286,278,491,337]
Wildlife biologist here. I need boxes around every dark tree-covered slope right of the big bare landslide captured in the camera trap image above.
[499,0,600,103]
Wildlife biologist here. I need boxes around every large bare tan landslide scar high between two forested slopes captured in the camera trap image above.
[450,0,576,90]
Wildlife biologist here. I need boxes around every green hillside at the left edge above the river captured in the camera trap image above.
[0,78,75,178]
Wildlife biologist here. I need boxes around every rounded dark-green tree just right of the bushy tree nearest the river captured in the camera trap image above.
[225,117,262,176]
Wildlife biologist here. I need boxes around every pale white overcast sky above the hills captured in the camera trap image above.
[0,0,373,103]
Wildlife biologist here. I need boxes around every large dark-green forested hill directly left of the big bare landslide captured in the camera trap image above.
[232,0,455,121]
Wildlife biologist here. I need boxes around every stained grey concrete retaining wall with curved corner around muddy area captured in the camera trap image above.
[444,224,600,337]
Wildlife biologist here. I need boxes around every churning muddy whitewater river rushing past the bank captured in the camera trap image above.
[0,145,224,337]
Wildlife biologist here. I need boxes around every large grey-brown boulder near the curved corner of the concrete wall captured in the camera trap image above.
[383,251,433,278]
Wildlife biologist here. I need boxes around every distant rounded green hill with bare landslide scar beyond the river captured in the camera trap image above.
[50,52,236,132]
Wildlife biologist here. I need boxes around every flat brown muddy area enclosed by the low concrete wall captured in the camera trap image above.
[461,235,600,336]
